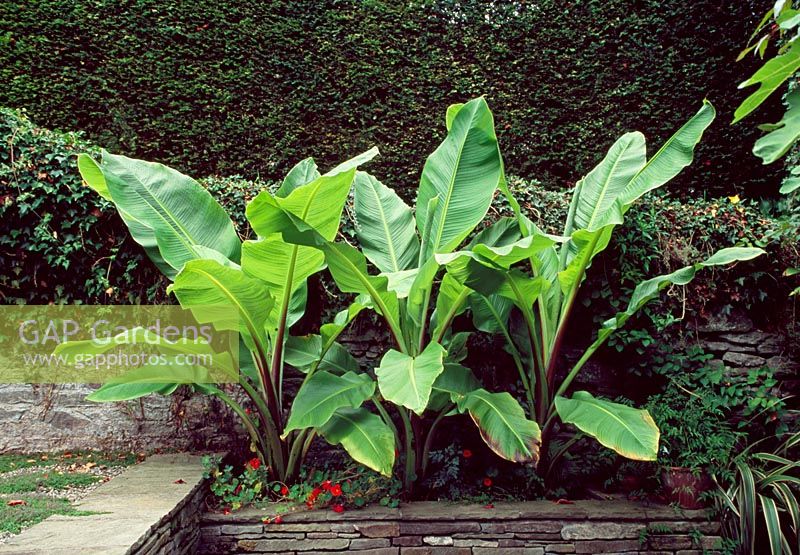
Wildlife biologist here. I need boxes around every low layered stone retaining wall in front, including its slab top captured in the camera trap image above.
[198,500,720,555]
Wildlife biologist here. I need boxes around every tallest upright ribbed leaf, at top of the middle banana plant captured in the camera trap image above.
[416,98,502,254]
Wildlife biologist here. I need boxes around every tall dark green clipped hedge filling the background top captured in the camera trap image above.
[0,0,777,196]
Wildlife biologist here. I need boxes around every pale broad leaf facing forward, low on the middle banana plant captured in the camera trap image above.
[375,343,445,415]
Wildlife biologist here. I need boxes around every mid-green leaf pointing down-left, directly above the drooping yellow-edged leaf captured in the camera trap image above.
[283,372,375,437]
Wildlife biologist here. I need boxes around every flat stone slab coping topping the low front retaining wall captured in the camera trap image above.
[202,499,710,530]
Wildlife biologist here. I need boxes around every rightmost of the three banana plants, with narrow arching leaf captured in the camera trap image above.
[435,101,763,477]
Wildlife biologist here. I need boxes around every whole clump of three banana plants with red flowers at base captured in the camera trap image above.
[58,98,762,510]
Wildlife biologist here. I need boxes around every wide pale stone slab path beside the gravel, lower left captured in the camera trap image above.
[0,454,204,555]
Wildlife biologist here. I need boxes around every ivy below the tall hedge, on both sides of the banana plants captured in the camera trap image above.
[0,109,800,320]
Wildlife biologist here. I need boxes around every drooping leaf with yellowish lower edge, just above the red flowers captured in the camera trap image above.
[320,407,395,476]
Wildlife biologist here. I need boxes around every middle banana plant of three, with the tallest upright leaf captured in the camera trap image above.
[270,98,544,494]
